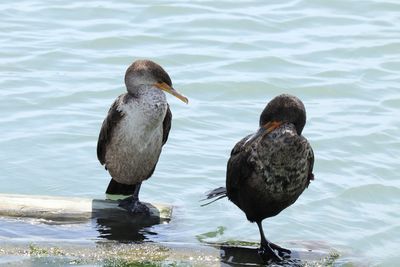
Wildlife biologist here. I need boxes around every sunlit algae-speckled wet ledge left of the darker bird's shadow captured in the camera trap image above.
[0,242,219,267]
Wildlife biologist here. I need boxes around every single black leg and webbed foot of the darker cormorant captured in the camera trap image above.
[257,221,291,262]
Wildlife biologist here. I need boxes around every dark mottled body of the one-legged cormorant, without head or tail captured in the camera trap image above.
[226,123,314,222]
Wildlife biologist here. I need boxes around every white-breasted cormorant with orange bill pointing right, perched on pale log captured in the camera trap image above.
[97,59,188,215]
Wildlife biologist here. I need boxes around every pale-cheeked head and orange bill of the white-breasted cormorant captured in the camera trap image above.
[125,60,189,104]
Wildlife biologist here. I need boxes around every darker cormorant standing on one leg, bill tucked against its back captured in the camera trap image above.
[202,94,314,262]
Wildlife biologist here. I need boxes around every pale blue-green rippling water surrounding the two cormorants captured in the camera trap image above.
[0,0,400,266]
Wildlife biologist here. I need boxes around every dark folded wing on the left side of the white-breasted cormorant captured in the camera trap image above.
[97,95,124,168]
